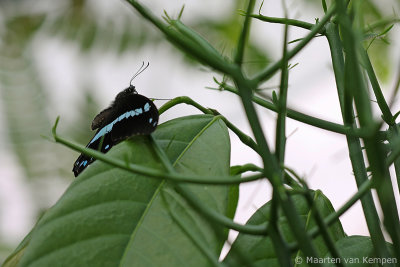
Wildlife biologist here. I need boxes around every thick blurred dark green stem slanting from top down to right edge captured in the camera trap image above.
[337,1,400,261]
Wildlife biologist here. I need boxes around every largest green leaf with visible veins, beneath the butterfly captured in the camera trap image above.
[11,115,237,266]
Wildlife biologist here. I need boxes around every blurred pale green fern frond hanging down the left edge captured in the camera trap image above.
[0,13,54,177]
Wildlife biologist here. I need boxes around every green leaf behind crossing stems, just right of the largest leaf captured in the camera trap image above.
[224,191,345,266]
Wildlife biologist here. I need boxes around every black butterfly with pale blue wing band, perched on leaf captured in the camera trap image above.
[72,86,158,177]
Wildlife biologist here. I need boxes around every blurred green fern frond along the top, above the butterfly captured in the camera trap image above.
[41,0,160,54]
